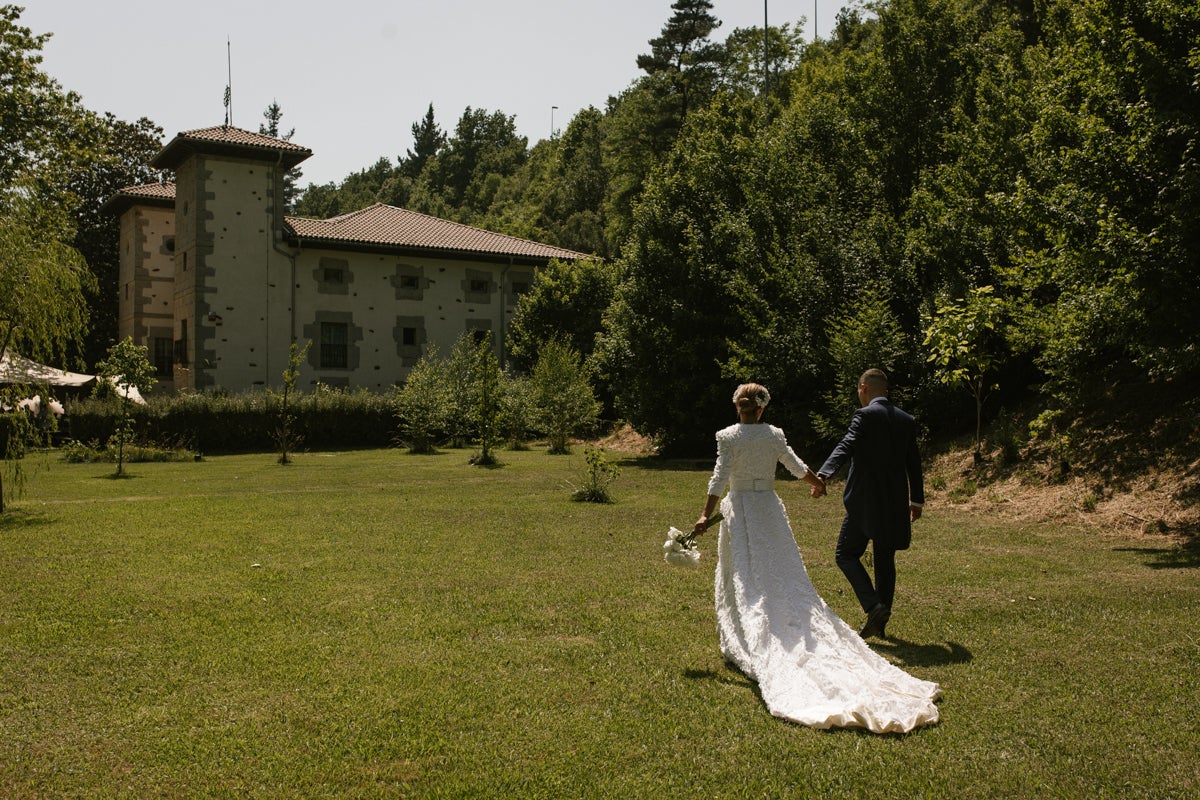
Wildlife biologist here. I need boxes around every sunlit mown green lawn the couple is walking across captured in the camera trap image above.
[0,450,1200,798]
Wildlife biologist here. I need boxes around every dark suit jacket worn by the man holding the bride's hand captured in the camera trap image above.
[817,397,925,551]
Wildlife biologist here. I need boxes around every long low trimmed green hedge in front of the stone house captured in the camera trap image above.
[61,390,396,453]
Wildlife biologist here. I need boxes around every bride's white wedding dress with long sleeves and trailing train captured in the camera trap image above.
[708,423,941,733]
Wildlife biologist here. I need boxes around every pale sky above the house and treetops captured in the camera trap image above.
[16,0,851,186]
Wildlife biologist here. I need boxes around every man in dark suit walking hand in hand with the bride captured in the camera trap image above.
[812,369,925,639]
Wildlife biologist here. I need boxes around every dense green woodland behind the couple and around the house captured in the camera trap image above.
[0,0,1200,465]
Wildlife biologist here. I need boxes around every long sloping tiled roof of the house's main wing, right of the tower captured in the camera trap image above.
[284,203,590,260]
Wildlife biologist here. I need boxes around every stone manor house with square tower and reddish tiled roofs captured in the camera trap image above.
[106,126,588,392]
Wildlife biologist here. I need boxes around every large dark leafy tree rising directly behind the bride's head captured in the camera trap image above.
[596,96,796,452]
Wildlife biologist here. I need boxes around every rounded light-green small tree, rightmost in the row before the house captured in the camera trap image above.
[530,339,600,455]
